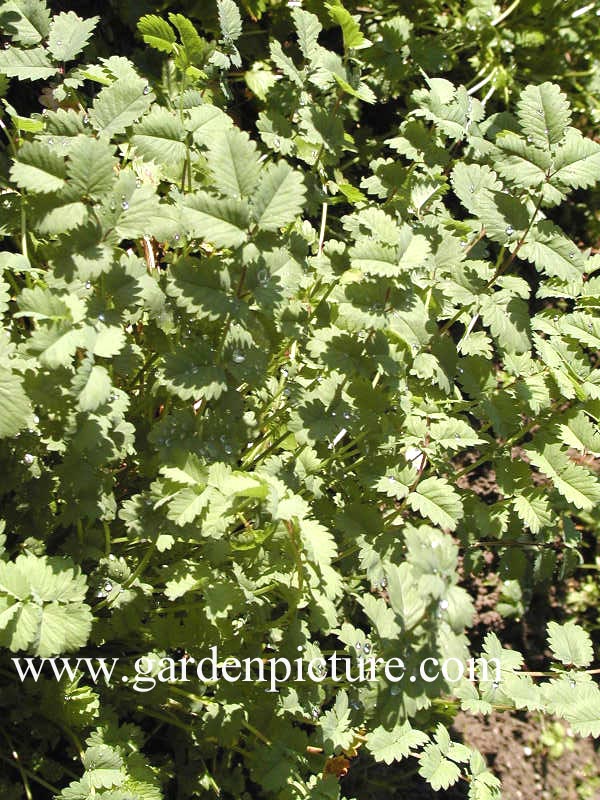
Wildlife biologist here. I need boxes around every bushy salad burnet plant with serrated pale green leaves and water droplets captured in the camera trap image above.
[0,0,600,800]
